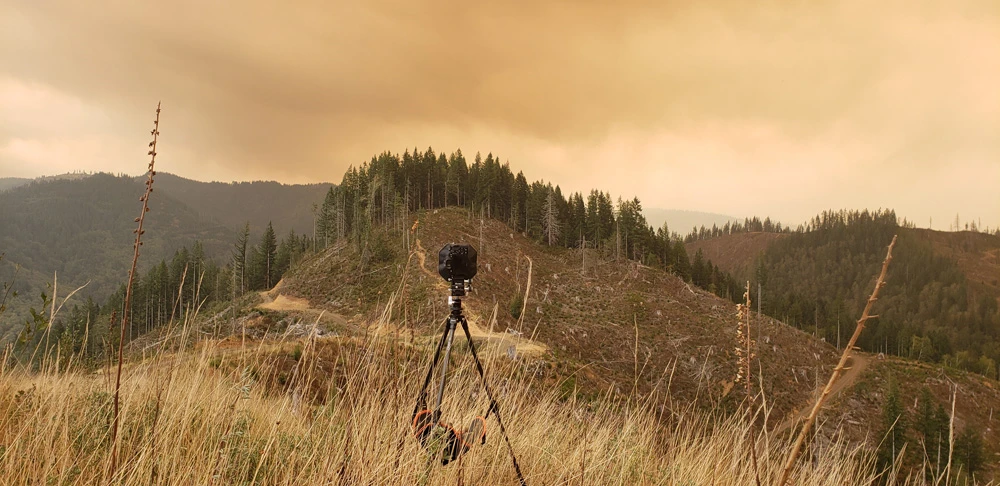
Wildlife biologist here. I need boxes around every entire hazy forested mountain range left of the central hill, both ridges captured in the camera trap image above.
[0,172,332,341]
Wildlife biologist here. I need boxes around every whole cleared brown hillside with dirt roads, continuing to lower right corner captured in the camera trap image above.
[236,208,1000,479]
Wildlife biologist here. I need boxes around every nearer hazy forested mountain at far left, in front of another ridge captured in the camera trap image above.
[0,174,235,336]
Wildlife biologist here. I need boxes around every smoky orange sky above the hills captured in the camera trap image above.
[0,0,1000,229]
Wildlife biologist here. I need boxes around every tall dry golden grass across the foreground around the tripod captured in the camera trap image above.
[0,320,892,486]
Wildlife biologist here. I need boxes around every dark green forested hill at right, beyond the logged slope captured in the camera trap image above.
[686,211,1000,378]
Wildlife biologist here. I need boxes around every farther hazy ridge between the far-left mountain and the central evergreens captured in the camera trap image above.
[156,173,333,235]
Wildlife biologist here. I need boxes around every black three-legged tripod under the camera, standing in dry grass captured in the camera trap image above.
[413,280,527,486]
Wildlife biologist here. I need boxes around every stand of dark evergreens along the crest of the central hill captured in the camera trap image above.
[318,148,742,297]
